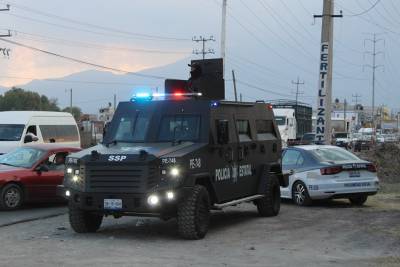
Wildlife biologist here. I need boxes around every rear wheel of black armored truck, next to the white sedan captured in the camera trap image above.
[255,175,281,217]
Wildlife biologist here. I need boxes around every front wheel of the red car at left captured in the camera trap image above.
[0,183,24,210]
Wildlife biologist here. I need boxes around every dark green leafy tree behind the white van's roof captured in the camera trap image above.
[0,87,60,111]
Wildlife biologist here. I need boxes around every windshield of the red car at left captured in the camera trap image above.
[0,147,46,168]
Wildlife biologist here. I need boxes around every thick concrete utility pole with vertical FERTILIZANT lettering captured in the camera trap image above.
[314,0,343,144]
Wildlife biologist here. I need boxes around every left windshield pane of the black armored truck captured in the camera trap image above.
[113,112,150,143]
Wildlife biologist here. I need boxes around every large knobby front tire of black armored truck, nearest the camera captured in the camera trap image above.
[178,185,210,239]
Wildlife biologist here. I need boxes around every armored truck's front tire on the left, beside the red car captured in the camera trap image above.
[68,205,103,233]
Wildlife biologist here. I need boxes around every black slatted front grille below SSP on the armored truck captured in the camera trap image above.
[86,164,158,193]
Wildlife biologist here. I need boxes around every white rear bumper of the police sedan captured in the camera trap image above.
[307,179,379,199]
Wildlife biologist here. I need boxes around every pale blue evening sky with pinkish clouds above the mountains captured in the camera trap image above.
[0,0,400,109]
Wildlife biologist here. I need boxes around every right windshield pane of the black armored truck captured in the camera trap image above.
[158,115,200,142]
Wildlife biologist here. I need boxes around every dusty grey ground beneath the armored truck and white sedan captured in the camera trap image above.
[0,195,400,267]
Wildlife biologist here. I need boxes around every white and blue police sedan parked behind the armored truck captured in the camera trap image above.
[281,145,379,206]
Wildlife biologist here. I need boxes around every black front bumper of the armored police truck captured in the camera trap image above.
[57,186,192,216]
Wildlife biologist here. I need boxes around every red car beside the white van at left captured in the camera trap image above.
[0,144,80,210]
